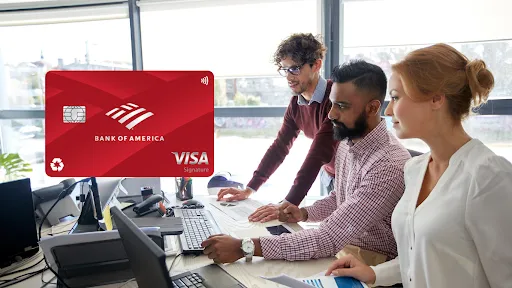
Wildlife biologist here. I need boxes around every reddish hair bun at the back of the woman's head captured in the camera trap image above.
[466,59,494,107]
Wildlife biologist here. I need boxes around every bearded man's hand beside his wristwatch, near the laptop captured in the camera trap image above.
[201,234,244,263]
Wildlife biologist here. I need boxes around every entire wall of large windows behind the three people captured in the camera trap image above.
[0,0,512,203]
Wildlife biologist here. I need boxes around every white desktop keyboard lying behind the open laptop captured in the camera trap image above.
[174,209,222,254]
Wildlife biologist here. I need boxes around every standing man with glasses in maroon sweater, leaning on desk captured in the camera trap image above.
[218,34,337,222]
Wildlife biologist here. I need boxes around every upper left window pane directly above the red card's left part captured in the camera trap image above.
[0,19,132,110]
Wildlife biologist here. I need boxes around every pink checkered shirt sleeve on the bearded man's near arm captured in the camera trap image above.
[260,160,405,261]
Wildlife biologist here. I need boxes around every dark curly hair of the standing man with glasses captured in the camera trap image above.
[274,33,327,66]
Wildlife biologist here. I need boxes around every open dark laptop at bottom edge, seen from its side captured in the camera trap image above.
[110,207,246,288]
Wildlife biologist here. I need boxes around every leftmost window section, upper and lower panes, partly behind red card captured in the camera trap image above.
[0,15,132,187]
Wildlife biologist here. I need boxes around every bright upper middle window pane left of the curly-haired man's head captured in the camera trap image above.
[140,0,320,78]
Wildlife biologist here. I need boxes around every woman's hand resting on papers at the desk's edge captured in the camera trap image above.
[325,255,376,284]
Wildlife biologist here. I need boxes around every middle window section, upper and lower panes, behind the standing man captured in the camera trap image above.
[140,0,320,202]
